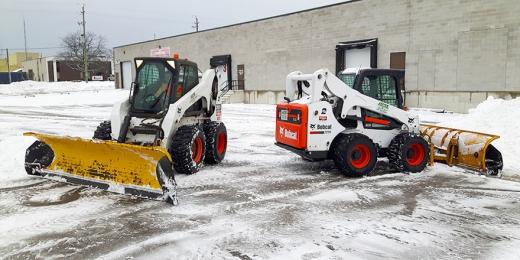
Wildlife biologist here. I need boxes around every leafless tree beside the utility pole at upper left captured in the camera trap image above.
[59,32,111,78]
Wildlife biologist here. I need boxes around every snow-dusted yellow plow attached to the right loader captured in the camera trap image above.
[421,125,503,175]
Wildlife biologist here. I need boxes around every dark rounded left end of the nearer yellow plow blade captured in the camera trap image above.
[25,141,54,175]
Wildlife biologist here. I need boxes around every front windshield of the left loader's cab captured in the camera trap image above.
[133,61,173,113]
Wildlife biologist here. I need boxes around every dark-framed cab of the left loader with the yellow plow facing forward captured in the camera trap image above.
[130,57,199,115]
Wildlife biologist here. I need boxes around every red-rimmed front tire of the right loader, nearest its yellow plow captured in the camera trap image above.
[388,133,430,172]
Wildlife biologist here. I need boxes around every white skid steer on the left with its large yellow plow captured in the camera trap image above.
[25,56,231,204]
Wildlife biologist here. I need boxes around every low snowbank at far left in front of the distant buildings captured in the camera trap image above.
[0,81,115,95]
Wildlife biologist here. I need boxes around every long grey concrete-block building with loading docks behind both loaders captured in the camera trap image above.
[114,0,520,112]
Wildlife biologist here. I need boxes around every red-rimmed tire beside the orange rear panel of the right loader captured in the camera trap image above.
[332,134,377,177]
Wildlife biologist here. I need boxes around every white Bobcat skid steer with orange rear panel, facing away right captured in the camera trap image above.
[276,69,501,176]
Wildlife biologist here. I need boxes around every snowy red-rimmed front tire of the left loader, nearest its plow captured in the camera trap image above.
[170,126,206,174]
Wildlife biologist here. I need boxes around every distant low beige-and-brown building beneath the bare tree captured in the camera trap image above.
[22,57,113,82]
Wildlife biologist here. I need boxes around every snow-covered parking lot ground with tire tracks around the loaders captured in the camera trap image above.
[0,82,520,259]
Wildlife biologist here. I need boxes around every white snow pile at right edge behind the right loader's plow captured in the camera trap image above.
[440,97,520,178]
